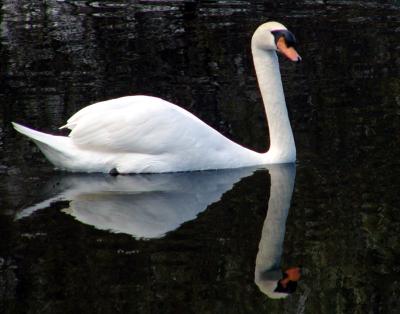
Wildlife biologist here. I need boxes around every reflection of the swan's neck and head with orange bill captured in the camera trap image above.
[255,164,300,299]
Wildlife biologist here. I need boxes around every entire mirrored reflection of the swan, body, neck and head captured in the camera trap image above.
[18,164,300,298]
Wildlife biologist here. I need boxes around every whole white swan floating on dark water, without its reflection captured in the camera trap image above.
[13,22,301,173]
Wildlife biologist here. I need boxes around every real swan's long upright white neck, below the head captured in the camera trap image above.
[252,45,296,163]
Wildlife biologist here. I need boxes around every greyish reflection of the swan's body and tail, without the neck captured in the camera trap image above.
[18,168,257,239]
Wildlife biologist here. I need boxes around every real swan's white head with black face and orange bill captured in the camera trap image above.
[251,22,301,62]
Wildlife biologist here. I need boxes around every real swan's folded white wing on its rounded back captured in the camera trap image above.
[66,96,232,154]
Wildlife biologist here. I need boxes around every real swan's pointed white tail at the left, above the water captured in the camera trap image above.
[12,122,73,169]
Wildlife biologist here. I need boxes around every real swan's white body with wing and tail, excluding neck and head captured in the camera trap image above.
[16,96,272,173]
